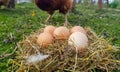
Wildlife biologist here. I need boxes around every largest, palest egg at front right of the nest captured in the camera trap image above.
[68,32,88,52]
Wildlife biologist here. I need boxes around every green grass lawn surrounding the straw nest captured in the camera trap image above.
[0,3,120,72]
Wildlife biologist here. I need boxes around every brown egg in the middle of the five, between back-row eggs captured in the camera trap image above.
[53,26,70,40]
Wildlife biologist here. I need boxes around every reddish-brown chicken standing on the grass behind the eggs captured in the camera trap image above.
[35,0,73,26]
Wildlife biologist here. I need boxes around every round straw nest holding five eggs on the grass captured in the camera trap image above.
[10,28,120,72]
